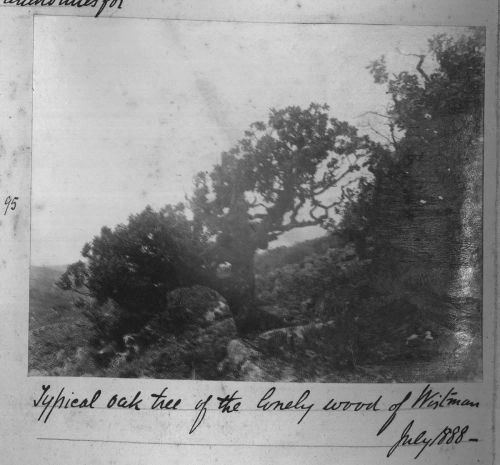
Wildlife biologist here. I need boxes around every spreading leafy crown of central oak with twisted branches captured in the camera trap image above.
[191,104,382,249]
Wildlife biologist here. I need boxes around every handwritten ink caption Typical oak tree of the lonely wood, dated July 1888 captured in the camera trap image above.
[33,385,479,459]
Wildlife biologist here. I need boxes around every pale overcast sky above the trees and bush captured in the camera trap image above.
[32,16,468,265]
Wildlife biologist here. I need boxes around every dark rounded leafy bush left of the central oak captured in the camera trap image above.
[59,205,206,337]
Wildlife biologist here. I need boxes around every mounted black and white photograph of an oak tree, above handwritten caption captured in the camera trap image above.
[28,16,485,383]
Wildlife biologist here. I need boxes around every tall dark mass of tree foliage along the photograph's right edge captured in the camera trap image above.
[341,29,485,304]
